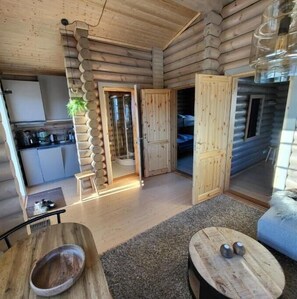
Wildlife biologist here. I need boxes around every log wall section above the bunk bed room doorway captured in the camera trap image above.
[164,12,222,88]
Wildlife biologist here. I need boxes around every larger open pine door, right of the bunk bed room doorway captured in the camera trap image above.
[192,74,232,204]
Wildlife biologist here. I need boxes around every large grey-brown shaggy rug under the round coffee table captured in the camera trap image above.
[101,195,297,299]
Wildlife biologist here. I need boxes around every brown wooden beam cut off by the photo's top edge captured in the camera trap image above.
[172,0,223,13]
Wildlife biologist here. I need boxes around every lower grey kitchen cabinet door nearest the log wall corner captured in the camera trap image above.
[62,144,80,177]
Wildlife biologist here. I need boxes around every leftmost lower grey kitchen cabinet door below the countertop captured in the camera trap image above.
[20,148,44,186]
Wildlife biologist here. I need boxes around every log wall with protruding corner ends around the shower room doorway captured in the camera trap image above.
[61,26,153,190]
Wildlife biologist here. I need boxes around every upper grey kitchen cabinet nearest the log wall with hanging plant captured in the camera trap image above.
[38,75,70,120]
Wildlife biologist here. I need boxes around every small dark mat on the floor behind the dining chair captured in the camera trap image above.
[26,187,66,218]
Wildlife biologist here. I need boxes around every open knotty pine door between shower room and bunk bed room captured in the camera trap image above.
[141,89,171,177]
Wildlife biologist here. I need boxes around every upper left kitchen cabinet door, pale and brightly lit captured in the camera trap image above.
[2,80,45,122]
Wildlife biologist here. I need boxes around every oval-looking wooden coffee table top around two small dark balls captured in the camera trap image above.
[189,227,285,299]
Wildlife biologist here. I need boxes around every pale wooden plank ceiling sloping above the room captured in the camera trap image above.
[0,0,230,75]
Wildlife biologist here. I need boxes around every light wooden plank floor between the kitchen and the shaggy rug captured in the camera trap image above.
[29,173,192,254]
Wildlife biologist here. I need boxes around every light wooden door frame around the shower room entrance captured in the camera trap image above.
[98,82,142,185]
